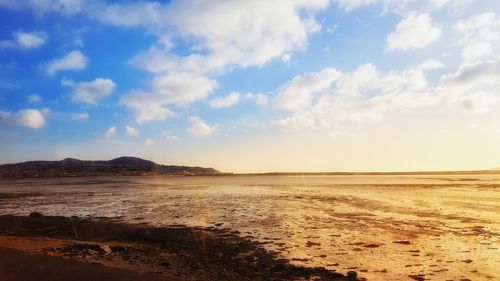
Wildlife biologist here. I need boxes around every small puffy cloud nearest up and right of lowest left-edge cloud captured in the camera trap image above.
[61,78,116,104]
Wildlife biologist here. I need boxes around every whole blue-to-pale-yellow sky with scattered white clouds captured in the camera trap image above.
[0,0,500,172]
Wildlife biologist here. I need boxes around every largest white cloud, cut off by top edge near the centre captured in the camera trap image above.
[127,0,328,73]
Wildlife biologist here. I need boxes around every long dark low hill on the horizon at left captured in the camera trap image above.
[0,156,220,178]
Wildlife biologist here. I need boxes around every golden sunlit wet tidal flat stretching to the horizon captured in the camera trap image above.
[0,175,500,280]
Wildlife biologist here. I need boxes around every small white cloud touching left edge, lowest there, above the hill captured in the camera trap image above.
[0,109,45,129]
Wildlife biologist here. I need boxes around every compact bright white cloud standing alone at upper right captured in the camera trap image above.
[387,14,441,51]
